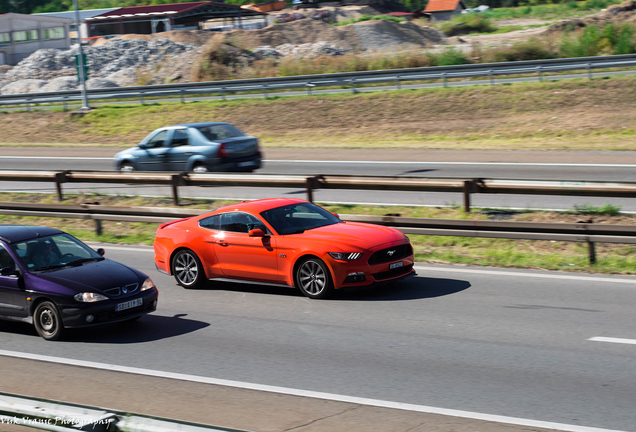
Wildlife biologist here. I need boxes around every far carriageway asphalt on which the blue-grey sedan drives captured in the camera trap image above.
[0,147,636,212]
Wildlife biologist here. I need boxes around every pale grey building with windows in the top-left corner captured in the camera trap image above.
[0,13,71,66]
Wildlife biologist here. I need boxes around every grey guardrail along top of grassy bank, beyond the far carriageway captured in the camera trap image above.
[0,54,636,107]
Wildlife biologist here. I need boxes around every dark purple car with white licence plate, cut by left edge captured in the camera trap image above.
[0,225,158,340]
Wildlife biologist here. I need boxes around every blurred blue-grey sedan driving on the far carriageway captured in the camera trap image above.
[115,122,261,172]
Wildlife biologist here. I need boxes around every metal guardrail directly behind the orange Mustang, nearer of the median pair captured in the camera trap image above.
[0,202,636,263]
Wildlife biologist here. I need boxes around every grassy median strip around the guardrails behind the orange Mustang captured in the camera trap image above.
[0,193,636,275]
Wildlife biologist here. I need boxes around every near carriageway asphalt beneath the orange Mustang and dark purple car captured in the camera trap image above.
[0,245,636,430]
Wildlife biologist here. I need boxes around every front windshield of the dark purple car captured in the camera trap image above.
[11,234,103,271]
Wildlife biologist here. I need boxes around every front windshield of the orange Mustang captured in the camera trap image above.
[261,203,342,235]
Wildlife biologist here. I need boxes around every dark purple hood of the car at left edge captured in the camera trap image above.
[38,259,142,292]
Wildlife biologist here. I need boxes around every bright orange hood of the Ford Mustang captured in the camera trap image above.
[294,222,408,249]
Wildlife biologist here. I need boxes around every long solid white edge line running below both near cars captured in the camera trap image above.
[0,350,621,432]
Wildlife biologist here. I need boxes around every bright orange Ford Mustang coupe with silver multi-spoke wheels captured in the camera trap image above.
[154,198,414,298]
